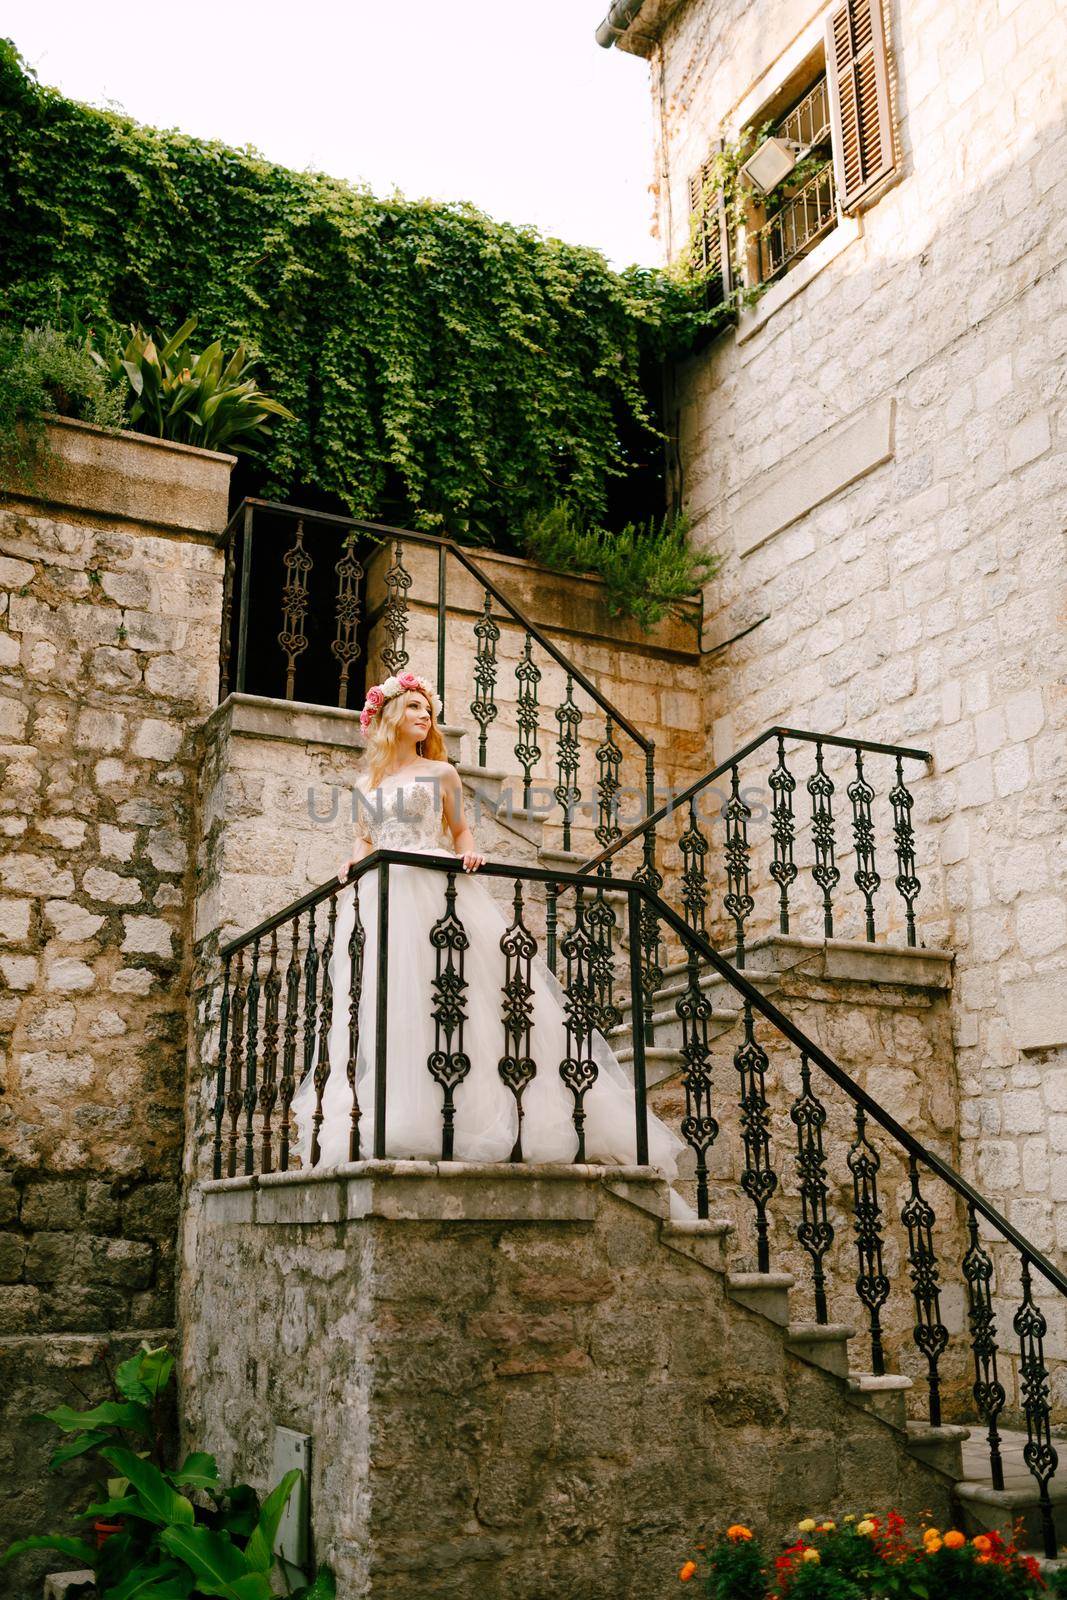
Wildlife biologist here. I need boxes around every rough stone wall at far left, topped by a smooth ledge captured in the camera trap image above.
[0,424,232,1600]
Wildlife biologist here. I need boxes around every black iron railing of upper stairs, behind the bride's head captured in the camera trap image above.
[219,499,656,851]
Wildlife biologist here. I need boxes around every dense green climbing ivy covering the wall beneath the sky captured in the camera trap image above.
[0,43,723,541]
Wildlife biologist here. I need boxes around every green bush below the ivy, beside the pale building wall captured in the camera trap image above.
[522,504,717,629]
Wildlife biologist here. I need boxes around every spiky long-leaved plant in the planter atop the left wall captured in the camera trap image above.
[93,317,294,451]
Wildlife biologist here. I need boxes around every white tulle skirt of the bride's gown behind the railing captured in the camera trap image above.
[293,851,685,1178]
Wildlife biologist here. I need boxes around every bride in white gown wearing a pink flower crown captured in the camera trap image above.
[293,672,685,1178]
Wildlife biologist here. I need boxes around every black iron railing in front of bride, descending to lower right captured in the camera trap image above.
[213,851,1067,1555]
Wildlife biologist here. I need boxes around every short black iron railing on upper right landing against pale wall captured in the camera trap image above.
[581,726,931,1045]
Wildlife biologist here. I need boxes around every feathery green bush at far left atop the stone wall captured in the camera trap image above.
[0,325,125,483]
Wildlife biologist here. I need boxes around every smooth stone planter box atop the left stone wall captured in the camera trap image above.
[3,418,237,534]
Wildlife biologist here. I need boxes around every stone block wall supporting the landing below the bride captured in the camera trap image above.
[182,1163,949,1600]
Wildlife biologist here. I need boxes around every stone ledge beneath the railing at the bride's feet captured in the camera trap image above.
[197,1162,669,1226]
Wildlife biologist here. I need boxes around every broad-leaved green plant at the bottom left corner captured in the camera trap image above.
[0,1346,336,1600]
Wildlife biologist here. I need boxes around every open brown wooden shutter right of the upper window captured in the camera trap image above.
[825,0,896,211]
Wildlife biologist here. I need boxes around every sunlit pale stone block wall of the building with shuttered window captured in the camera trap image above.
[633,0,1067,1250]
